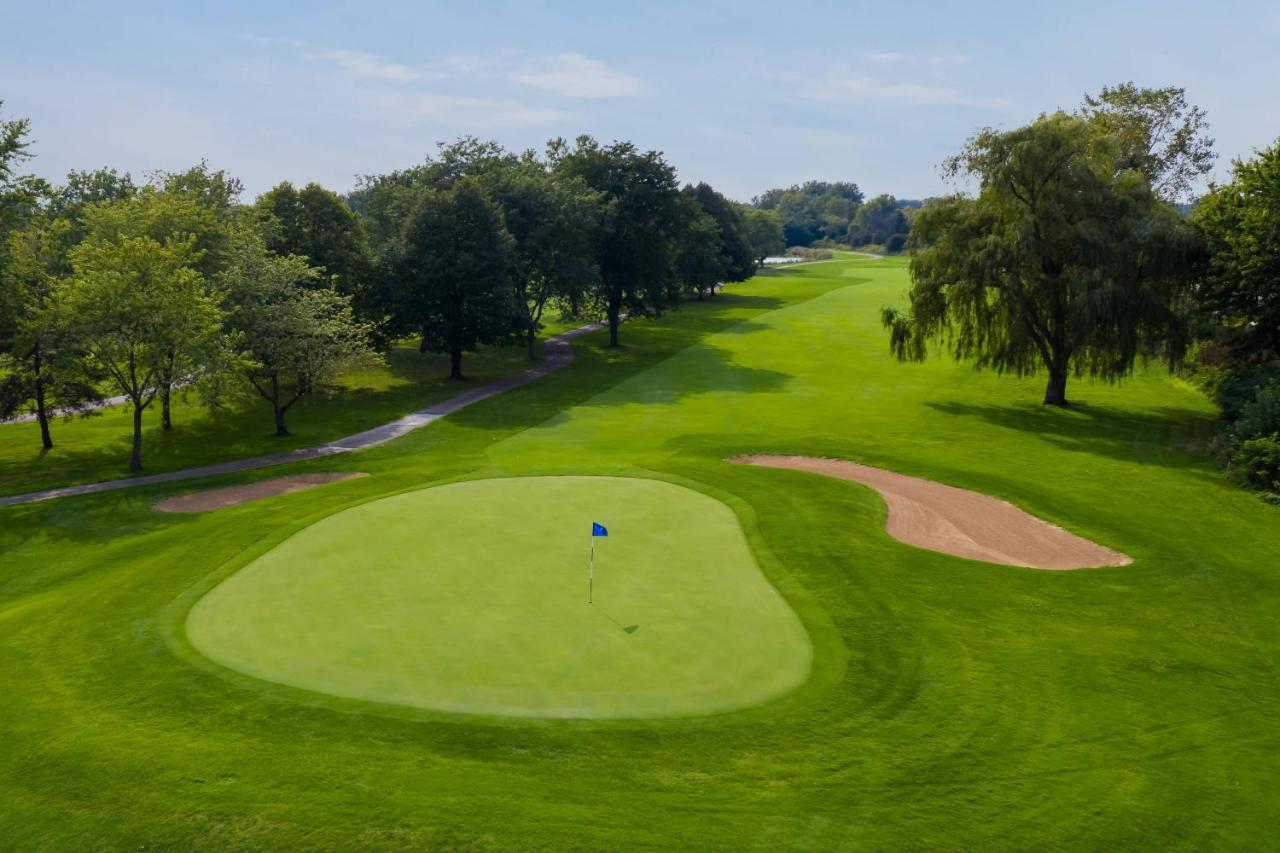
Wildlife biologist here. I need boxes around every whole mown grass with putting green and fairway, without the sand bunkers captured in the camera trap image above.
[0,257,1280,850]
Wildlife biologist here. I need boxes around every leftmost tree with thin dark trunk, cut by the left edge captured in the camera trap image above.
[0,218,101,451]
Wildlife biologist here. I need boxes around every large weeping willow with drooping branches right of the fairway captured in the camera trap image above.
[883,113,1199,406]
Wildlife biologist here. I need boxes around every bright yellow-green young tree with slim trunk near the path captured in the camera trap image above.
[52,236,224,471]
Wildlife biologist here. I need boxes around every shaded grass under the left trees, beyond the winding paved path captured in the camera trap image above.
[0,346,540,494]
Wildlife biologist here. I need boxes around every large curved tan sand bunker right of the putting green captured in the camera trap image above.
[731,456,1133,569]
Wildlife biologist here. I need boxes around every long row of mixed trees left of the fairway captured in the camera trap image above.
[0,111,782,471]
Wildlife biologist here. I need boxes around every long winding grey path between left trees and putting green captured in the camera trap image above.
[0,323,604,506]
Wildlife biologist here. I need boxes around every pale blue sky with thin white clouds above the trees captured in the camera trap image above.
[0,0,1280,201]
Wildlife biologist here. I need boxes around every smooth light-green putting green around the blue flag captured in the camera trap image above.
[187,476,812,719]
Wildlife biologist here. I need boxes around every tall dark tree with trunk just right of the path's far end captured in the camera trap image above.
[549,136,680,347]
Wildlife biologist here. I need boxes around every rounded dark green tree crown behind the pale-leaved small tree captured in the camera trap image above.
[253,181,372,313]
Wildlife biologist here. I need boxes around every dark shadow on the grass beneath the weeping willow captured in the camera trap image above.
[925,401,1217,478]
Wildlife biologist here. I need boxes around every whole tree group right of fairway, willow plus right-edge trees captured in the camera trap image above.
[883,83,1280,501]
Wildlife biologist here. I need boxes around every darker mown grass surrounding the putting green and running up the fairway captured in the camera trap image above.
[0,260,1280,850]
